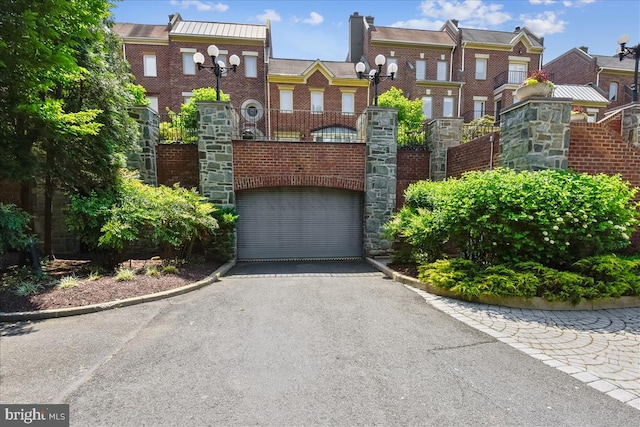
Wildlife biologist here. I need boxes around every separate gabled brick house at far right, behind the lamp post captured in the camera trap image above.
[543,45,635,108]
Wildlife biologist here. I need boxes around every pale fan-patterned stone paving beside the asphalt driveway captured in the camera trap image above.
[406,285,640,409]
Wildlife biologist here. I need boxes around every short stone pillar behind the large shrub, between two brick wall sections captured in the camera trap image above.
[426,118,464,181]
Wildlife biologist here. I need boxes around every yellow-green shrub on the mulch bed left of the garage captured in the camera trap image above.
[67,170,218,259]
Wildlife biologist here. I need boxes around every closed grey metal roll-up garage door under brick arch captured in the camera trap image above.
[236,187,362,260]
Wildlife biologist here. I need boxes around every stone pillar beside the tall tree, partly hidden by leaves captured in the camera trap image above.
[127,106,160,187]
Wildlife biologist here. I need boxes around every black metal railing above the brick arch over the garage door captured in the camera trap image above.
[238,109,364,142]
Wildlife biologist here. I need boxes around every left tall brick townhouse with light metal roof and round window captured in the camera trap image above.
[115,13,271,123]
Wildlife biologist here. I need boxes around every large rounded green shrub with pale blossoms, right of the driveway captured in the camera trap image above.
[385,169,640,266]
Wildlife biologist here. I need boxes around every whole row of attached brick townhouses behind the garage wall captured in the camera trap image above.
[115,12,544,130]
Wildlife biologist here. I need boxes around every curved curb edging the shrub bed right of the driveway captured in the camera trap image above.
[367,258,640,311]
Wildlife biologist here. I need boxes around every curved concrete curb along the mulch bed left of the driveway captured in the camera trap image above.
[0,259,236,323]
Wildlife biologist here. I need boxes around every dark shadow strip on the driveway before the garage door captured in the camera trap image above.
[226,260,380,277]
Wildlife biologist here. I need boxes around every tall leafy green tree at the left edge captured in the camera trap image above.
[0,0,136,253]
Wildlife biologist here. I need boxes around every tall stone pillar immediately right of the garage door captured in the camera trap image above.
[364,107,398,256]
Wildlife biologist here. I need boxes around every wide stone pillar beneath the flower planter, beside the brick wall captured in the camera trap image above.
[499,98,571,171]
